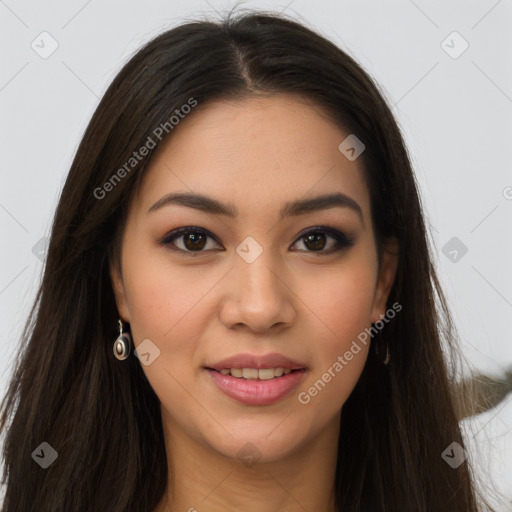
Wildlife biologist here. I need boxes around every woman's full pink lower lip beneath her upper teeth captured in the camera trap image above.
[206,369,306,405]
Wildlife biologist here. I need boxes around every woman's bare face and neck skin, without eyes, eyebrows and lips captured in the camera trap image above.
[111,94,398,512]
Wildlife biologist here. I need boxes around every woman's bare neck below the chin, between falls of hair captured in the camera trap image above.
[153,412,339,512]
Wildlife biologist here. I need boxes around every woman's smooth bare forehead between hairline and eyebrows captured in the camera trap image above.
[130,94,369,217]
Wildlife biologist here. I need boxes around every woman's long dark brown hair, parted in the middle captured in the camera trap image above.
[0,9,494,512]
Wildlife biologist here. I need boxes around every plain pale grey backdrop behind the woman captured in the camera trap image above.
[0,0,512,510]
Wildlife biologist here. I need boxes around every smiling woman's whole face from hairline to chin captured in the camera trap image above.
[112,94,396,461]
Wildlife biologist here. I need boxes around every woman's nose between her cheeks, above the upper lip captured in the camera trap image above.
[220,251,296,333]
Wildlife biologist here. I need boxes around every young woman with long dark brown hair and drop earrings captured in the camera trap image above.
[1,9,496,512]
